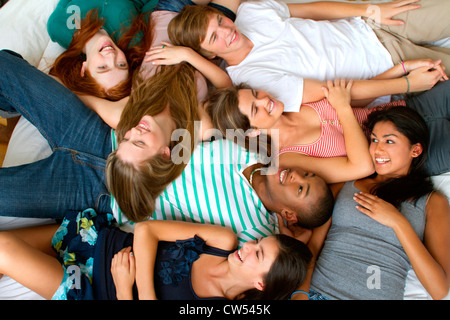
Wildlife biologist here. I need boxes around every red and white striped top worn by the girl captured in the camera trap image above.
[279,99,406,158]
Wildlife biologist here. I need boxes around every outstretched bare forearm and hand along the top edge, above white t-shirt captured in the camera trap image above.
[288,0,420,25]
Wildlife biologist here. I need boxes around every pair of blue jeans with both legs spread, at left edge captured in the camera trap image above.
[0,51,112,219]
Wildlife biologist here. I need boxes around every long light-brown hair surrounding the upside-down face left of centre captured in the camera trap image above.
[106,63,200,222]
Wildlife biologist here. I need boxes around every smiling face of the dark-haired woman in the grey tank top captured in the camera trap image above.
[369,121,422,178]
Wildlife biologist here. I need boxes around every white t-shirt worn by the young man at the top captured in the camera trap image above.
[227,0,393,112]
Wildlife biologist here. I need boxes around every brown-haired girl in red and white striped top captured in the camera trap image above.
[206,60,444,183]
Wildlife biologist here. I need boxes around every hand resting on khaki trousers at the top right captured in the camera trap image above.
[365,0,421,26]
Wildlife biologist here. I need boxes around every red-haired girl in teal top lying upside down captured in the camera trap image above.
[47,0,156,101]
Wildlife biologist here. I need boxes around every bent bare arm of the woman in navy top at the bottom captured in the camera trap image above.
[134,220,237,299]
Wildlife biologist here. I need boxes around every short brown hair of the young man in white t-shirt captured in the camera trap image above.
[167,5,222,57]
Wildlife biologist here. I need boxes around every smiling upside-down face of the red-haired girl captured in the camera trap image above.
[81,29,129,91]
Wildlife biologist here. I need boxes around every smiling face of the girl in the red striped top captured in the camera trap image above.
[238,89,284,129]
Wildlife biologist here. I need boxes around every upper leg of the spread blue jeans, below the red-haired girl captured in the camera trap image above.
[0,51,112,158]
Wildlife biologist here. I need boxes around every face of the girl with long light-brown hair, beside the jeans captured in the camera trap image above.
[117,116,170,168]
